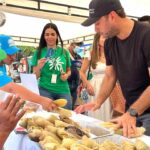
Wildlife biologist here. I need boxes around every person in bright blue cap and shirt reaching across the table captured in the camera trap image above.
[0,35,57,111]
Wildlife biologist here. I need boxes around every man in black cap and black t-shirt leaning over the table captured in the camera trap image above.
[75,0,150,137]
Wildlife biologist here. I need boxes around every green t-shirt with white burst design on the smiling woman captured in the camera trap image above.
[32,47,71,94]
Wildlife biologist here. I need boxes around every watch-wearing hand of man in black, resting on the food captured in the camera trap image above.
[111,112,137,138]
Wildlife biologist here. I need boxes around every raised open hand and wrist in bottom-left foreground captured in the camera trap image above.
[0,95,26,150]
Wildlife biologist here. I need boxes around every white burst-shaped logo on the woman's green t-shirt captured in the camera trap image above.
[48,57,64,72]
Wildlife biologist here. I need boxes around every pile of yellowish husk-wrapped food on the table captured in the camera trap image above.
[19,108,150,150]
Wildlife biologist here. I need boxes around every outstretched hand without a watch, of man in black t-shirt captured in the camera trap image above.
[74,102,95,114]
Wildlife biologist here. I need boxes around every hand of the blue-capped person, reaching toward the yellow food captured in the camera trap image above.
[40,97,58,111]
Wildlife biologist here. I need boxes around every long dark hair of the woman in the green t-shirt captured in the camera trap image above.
[37,23,63,59]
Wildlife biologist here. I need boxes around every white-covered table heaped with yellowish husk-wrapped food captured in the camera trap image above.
[4,108,150,150]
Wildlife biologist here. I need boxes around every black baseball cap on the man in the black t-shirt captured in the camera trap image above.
[82,0,122,26]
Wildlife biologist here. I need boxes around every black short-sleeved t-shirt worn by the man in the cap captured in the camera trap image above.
[105,22,150,107]
